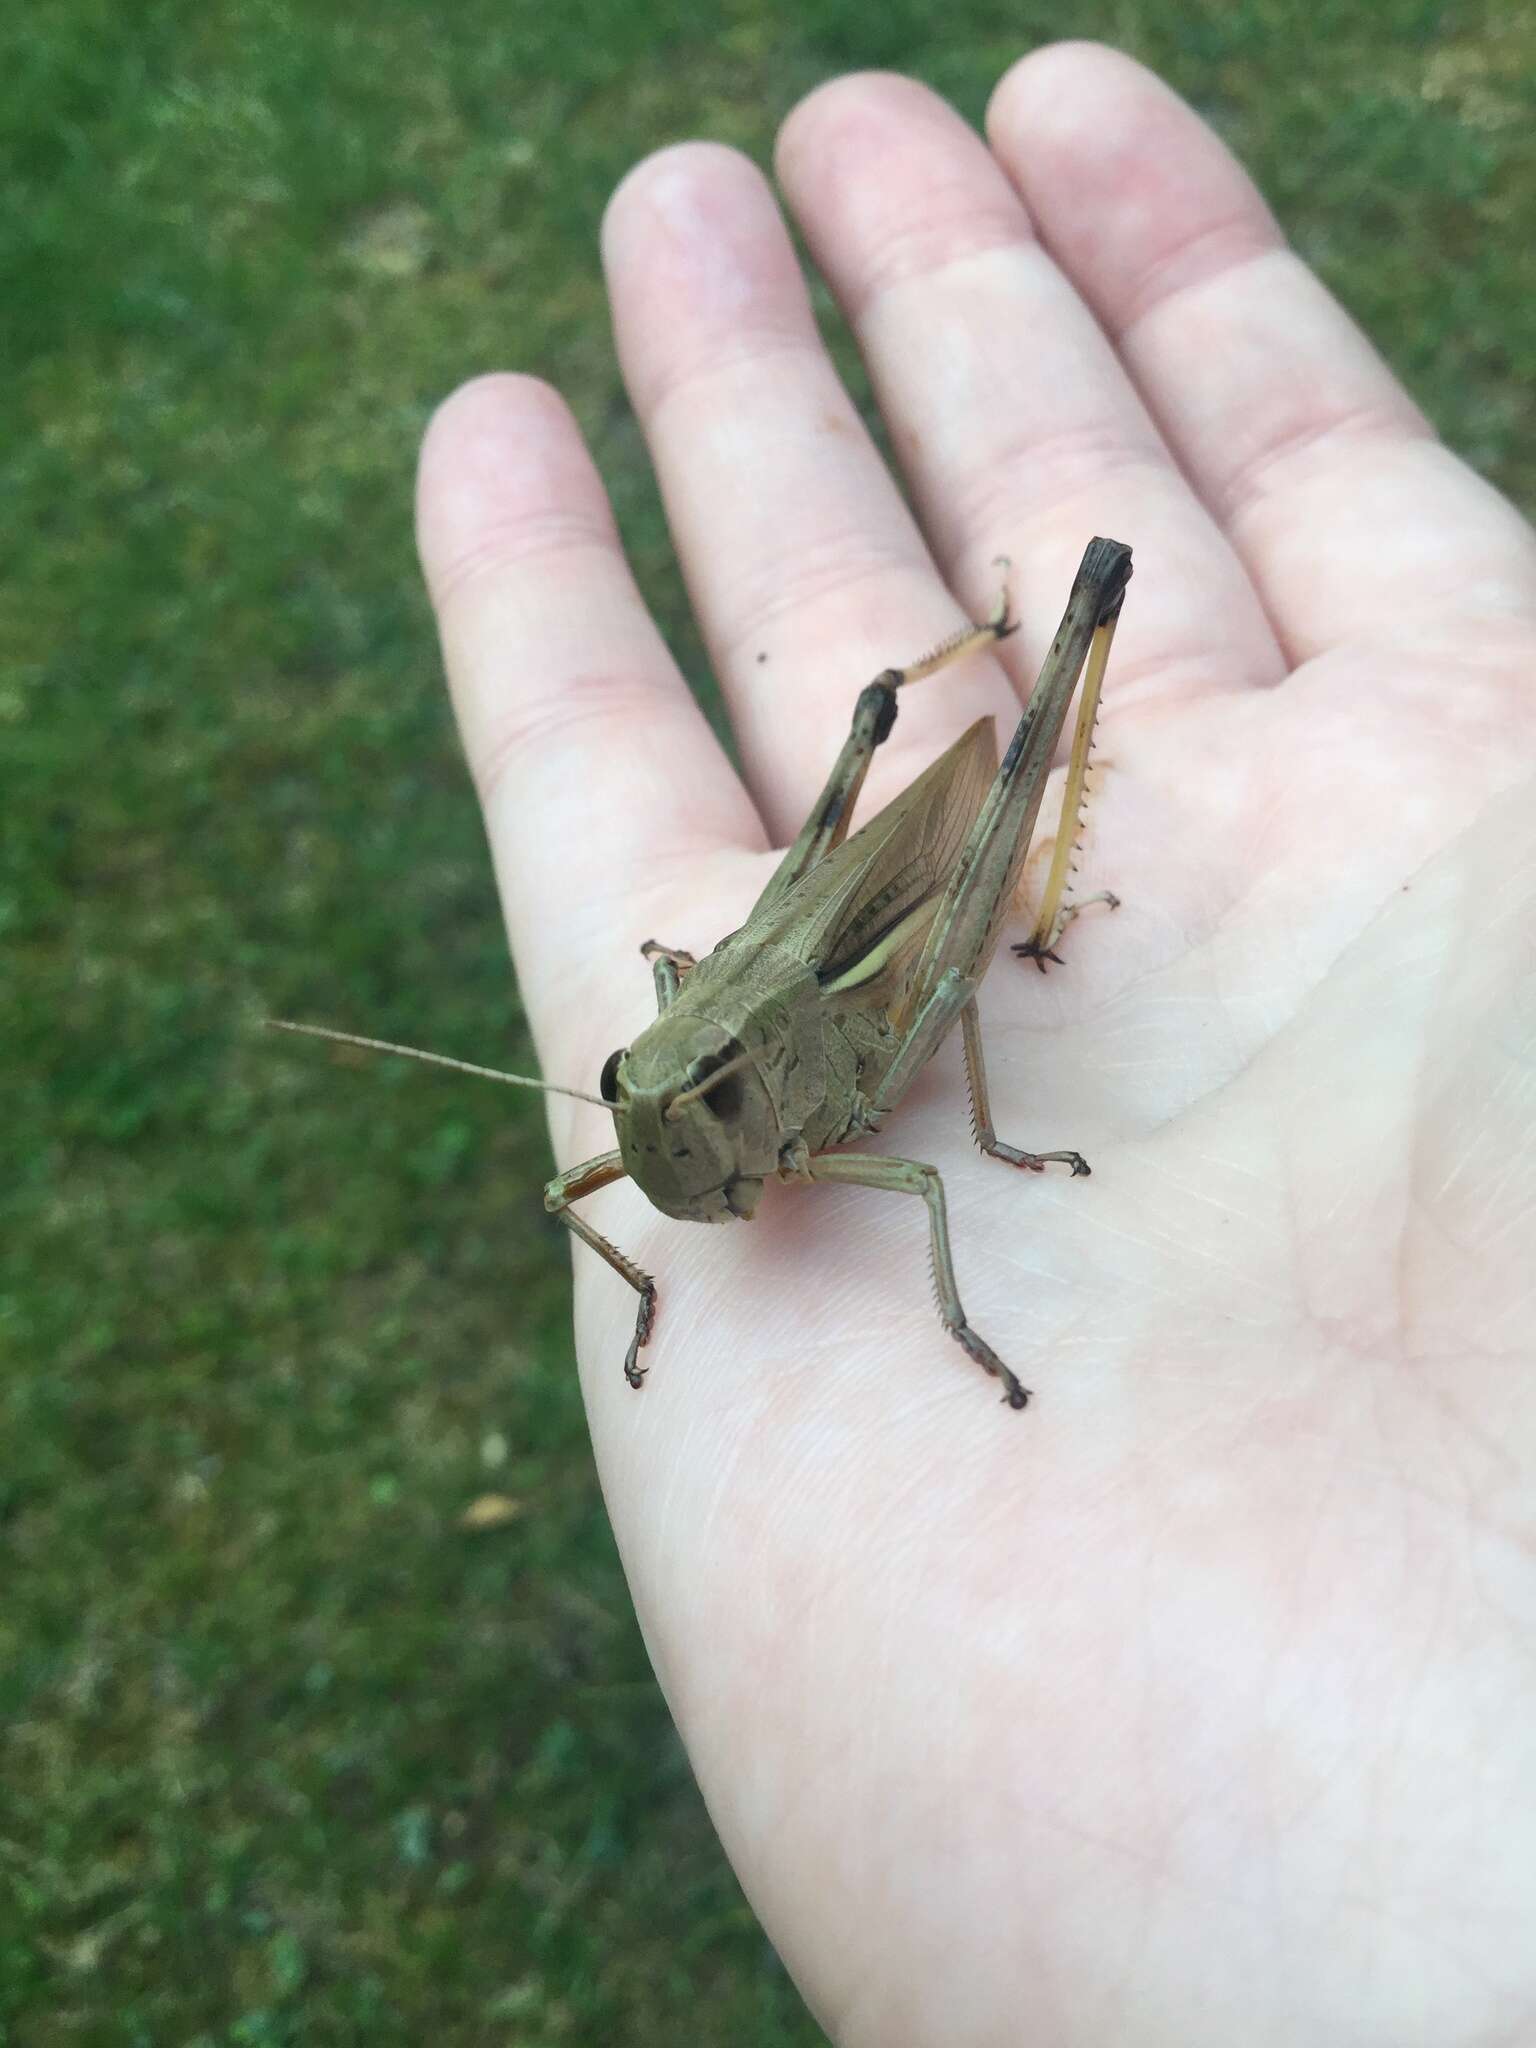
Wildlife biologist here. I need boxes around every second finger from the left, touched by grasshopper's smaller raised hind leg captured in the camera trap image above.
[602,143,1024,842]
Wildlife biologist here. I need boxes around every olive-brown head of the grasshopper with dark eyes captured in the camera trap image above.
[598,1016,778,1223]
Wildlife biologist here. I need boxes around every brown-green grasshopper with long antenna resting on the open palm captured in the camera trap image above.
[281,541,1130,1409]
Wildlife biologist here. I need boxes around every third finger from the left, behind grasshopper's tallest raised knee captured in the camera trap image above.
[778,76,1282,702]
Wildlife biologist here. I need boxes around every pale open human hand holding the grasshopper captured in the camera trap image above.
[420,45,1536,2048]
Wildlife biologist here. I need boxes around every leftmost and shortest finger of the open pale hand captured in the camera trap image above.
[418,377,762,1044]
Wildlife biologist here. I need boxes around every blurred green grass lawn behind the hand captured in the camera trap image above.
[0,0,1536,2048]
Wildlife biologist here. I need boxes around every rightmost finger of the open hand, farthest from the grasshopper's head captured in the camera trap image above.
[987,43,1536,657]
